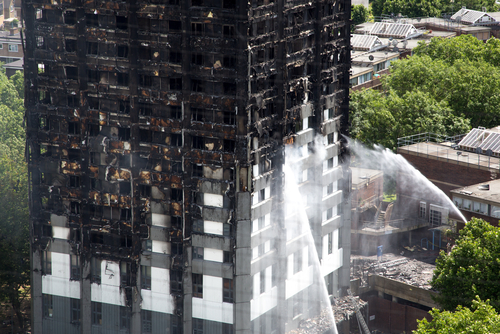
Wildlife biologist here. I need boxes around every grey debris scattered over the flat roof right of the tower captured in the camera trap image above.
[351,254,436,290]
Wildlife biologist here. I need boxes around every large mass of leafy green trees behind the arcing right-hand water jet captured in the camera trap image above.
[350,35,500,149]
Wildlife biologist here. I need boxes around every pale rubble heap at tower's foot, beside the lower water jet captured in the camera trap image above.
[288,296,368,334]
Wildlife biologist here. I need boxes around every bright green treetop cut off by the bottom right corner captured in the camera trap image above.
[413,298,500,334]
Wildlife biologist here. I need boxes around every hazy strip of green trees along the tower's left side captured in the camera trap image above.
[0,72,30,327]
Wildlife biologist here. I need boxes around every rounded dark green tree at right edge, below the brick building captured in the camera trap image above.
[431,218,500,311]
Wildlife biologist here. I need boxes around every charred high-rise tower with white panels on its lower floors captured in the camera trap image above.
[23,0,350,334]
